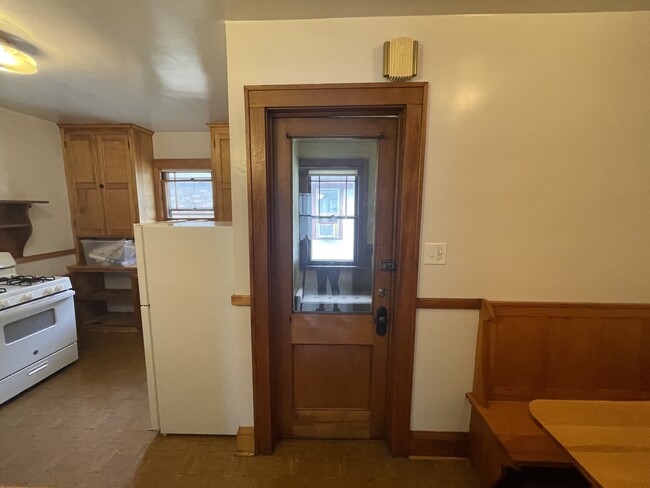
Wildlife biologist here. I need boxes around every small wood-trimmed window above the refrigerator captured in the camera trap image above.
[154,159,215,220]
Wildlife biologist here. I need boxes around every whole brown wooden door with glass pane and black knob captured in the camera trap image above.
[270,117,398,439]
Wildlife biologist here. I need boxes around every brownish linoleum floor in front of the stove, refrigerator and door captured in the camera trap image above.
[0,331,478,488]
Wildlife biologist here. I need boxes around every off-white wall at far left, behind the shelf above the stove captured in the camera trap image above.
[0,108,75,274]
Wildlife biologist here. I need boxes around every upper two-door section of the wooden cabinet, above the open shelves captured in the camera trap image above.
[60,124,156,242]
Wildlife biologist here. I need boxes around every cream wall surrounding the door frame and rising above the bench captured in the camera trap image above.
[226,12,650,431]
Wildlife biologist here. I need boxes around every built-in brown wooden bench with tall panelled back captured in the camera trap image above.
[467,300,650,487]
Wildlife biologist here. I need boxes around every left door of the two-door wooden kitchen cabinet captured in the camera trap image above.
[65,134,106,236]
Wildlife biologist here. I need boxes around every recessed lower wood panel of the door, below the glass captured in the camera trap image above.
[293,344,372,410]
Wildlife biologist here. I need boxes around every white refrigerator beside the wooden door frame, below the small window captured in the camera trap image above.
[135,222,239,435]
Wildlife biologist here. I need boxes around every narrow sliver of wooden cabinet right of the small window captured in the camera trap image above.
[208,122,232,222]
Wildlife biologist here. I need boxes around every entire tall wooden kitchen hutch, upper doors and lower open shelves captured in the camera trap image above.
[59,124,156,328]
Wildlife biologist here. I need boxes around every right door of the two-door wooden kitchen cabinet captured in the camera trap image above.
[96,134,135,236]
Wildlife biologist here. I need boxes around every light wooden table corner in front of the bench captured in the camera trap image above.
[530,400,650,488]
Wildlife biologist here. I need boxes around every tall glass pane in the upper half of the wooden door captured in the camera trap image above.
[292,138,377,313]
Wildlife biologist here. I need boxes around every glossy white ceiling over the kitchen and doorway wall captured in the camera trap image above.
[0,0,650,132]
